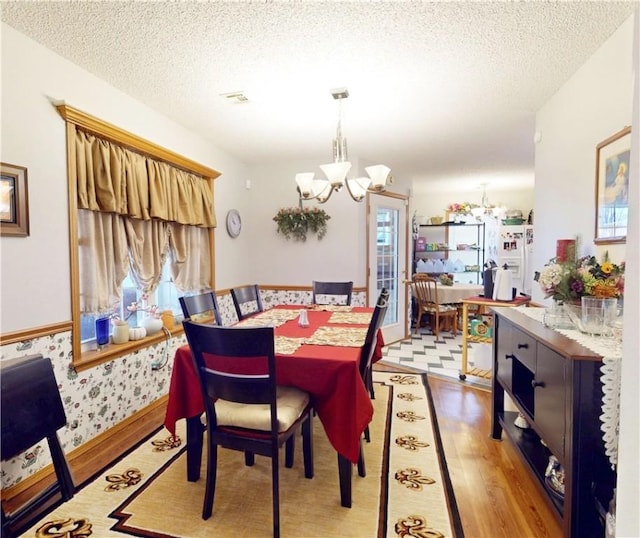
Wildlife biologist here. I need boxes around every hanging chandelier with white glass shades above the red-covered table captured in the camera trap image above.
[296,88,390,204]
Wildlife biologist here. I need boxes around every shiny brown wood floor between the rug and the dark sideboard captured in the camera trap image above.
[429,376,562,538]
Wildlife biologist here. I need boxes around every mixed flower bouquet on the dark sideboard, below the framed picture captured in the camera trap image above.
[536,253,625,302]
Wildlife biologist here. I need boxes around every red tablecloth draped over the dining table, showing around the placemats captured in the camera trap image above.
[164,307,383,463]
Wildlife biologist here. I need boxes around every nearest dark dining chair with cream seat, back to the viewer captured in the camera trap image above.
[184,320,313,537]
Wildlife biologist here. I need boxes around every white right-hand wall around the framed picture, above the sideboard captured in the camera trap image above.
[533,18,633,301]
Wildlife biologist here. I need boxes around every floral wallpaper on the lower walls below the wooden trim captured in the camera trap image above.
[0,290,366,489]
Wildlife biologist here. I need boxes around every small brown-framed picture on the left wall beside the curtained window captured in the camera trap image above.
[0,159,29,237]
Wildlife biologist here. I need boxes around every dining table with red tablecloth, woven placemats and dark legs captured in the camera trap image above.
[164,305,384,508]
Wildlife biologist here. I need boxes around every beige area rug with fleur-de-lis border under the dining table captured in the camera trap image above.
[23,372,462,538]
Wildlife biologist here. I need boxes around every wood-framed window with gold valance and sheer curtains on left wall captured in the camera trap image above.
[57,105,220,369]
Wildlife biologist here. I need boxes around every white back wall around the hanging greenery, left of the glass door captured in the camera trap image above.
[241,156,408,287]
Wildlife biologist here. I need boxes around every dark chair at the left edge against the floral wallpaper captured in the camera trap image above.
[0,354,75,538]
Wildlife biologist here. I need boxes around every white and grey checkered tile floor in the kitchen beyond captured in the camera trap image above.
[382,327,491,388]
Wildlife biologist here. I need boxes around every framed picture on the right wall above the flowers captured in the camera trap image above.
[594,127,631,244]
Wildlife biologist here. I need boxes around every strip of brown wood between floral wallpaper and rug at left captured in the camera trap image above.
[2,396,169,512]
